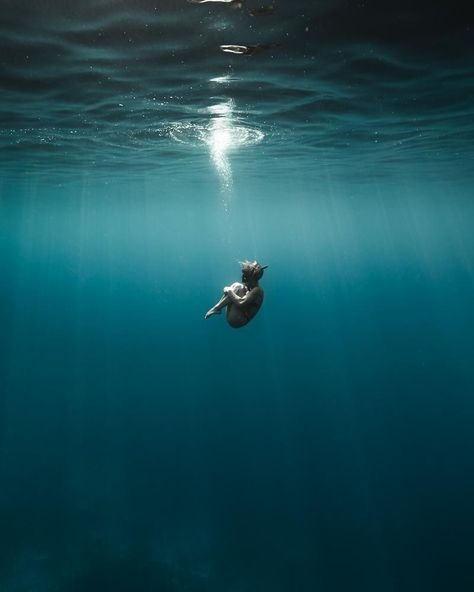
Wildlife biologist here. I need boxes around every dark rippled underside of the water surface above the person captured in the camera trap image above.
[0,0,473,182]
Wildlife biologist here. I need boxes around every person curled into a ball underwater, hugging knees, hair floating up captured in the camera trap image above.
[204,261,268,329]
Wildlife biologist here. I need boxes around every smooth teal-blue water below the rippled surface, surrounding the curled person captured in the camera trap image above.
[0,173,474,592]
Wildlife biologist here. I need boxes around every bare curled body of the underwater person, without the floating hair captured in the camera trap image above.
[204,280,263,329]
